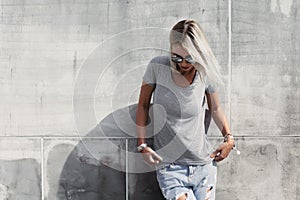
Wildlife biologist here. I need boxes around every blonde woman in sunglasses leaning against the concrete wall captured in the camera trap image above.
[136,20,234,200]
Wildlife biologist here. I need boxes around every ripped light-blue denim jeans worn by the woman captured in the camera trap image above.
[157,161,217,200]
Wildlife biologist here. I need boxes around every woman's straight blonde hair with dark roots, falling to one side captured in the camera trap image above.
[169,19,223,85]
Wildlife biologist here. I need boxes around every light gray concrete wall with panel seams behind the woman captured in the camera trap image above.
[0,0,300,200]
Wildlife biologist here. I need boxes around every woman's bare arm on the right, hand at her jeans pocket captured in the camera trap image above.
[206,92,234,162]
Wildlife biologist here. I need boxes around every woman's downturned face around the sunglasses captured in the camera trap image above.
[171,44,195,73]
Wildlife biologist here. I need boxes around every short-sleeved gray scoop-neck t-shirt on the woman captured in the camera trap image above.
[143,56,216,165]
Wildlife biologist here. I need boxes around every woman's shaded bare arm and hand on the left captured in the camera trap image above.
[136,81,162,165]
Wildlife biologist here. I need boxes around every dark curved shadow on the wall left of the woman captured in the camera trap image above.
[56,104,210,200]
